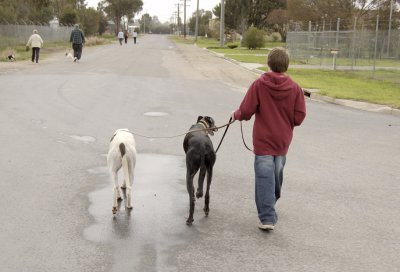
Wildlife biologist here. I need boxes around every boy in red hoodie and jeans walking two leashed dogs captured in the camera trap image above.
[232,47,306,230]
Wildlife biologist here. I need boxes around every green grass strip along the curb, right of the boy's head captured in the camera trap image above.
[288,69,400,108]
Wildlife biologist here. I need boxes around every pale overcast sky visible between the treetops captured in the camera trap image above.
[86,0,221,23]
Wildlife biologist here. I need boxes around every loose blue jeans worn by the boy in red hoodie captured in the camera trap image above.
[254,155,286,224]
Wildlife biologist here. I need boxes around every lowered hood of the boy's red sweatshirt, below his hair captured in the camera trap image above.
[260,72,294,100]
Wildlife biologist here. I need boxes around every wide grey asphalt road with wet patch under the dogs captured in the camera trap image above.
[0,35,400,272]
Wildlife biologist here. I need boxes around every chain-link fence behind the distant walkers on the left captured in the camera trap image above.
[0,24,73,48]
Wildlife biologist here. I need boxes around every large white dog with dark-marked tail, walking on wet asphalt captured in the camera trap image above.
[107,129,136,214]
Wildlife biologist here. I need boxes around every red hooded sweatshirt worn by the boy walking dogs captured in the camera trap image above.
[234,72,306,156]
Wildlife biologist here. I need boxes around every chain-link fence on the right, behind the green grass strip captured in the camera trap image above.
[287,19,400,69]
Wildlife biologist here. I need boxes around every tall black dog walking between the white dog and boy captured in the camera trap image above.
[183,116,217,225]
